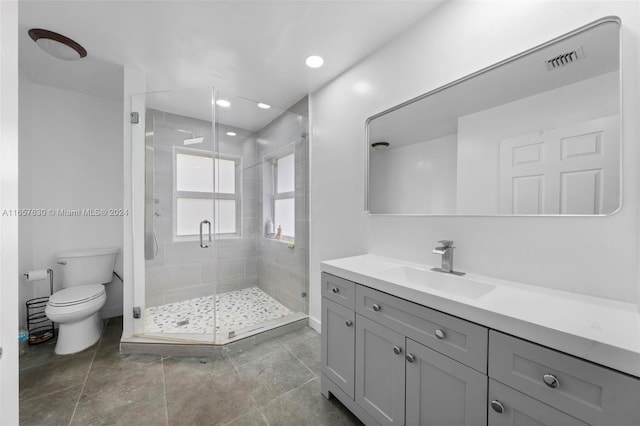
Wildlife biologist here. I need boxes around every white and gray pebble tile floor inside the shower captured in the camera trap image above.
[144,287,293,338]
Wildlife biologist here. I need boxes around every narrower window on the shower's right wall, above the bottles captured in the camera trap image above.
[273,154,295,241]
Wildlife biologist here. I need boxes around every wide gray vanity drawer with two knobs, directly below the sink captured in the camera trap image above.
[356,285,488,374]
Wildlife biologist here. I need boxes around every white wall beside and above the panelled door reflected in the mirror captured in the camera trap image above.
[458,72,620,214]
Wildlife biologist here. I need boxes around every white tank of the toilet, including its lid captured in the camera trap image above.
[56,247,120,288]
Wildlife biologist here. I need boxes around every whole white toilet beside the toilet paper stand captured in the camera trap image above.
[45,247,120,355]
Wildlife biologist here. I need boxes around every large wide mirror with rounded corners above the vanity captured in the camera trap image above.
[367,18,621,215]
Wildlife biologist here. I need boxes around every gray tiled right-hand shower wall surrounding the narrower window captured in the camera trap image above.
[257,97,309,313]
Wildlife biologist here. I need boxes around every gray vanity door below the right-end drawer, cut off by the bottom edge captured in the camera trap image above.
[489,379,587,426]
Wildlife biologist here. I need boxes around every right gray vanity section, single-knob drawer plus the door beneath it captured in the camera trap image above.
[489,330,640,426]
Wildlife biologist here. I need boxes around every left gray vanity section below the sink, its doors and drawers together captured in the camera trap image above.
[322,273,488,426]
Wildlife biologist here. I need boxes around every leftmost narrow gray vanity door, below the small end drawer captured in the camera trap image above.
[322,298,355,398]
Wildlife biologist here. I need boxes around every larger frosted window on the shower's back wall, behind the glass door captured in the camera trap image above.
[174,148,241,240]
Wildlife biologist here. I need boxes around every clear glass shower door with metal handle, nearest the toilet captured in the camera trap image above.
[134,89,218,343]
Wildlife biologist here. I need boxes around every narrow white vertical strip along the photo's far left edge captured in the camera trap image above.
[0,1,19,425]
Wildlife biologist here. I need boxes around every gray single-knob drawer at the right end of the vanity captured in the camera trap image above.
[489,330,640,426]
